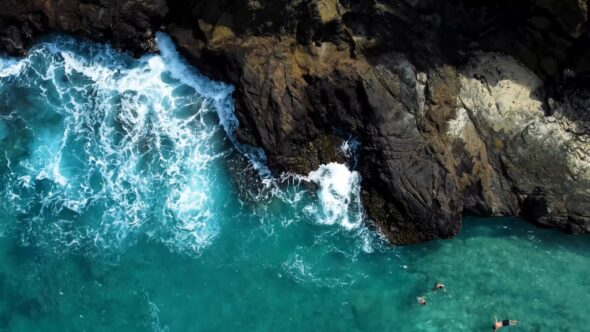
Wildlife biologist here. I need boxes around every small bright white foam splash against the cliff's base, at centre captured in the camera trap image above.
[245,160,383,256]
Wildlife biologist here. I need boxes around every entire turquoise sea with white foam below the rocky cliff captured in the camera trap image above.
[0,35,590,331]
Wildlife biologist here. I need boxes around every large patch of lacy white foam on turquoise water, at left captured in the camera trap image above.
[0,34,231,254]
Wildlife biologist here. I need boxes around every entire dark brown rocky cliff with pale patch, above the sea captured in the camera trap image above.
[0,0,590,244]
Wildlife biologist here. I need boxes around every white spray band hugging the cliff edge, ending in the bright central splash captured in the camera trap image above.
[156,32,370,246]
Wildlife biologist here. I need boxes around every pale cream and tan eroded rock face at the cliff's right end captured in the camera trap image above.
[448,54,590,232]
